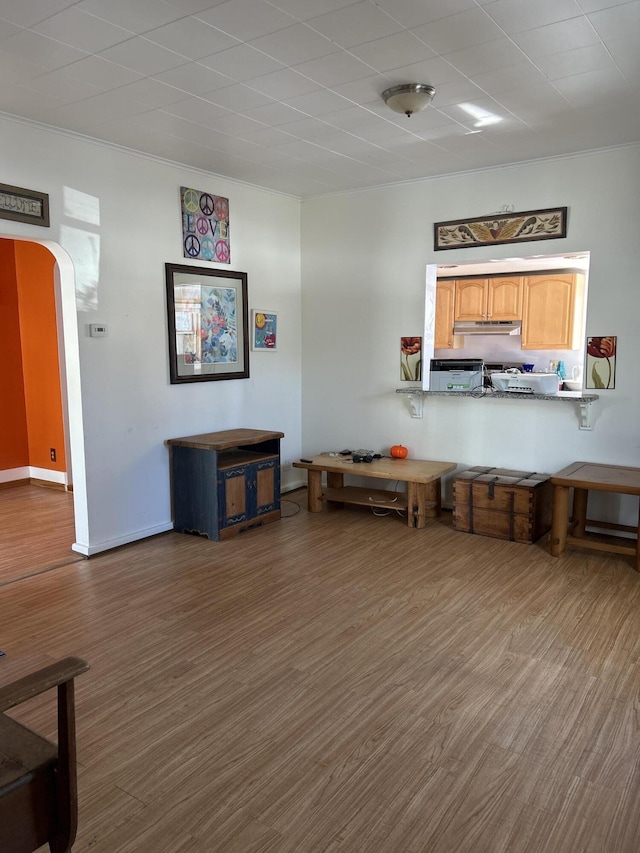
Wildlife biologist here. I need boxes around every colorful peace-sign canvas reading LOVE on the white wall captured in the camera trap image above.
[180,187,231,264]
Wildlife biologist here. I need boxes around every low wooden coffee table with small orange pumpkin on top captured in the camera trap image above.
[293,453,456,527]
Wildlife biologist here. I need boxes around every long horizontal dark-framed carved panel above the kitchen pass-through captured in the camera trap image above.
[433,207,568,252]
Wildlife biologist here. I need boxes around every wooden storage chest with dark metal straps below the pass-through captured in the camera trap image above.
[453,467,553,543]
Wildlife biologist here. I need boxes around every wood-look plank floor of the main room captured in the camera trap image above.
[0,492,640,853]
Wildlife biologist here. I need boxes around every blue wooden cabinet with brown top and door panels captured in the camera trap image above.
[167,429,284,541]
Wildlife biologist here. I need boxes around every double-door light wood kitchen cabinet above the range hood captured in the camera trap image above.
[452,276,523,321]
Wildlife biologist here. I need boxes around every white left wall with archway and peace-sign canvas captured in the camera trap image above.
[0,118,301,554]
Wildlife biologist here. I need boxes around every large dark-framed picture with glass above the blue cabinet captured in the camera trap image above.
[165,264,249,385]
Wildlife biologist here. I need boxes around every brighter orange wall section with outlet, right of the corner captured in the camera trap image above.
[15,241,66,471]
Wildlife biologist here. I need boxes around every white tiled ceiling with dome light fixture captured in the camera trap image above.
[0,0,640,197]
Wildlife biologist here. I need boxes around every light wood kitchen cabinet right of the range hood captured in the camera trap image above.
[522,273,584,350]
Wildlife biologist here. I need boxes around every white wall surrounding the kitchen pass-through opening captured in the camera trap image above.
[302,146,640,524]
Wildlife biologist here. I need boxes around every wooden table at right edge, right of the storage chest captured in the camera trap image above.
[551,462,640,571]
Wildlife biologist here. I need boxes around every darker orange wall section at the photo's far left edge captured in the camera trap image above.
[0,240,29,471]
